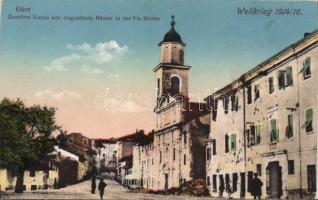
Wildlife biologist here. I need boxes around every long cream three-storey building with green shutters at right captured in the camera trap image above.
[206,28,318,198]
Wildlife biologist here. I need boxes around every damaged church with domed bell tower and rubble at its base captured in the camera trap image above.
[141,17,210,190]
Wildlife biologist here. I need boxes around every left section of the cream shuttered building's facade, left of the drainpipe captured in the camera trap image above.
[206,86,246,198]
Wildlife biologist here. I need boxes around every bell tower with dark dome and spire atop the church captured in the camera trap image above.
[153,16,190,97]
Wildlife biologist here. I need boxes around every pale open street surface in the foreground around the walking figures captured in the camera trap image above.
[0,180,216,200]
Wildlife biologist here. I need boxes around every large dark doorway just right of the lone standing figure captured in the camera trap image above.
[266,161,283,199]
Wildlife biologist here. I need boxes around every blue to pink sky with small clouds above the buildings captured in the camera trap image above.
[0,0,318,138]
